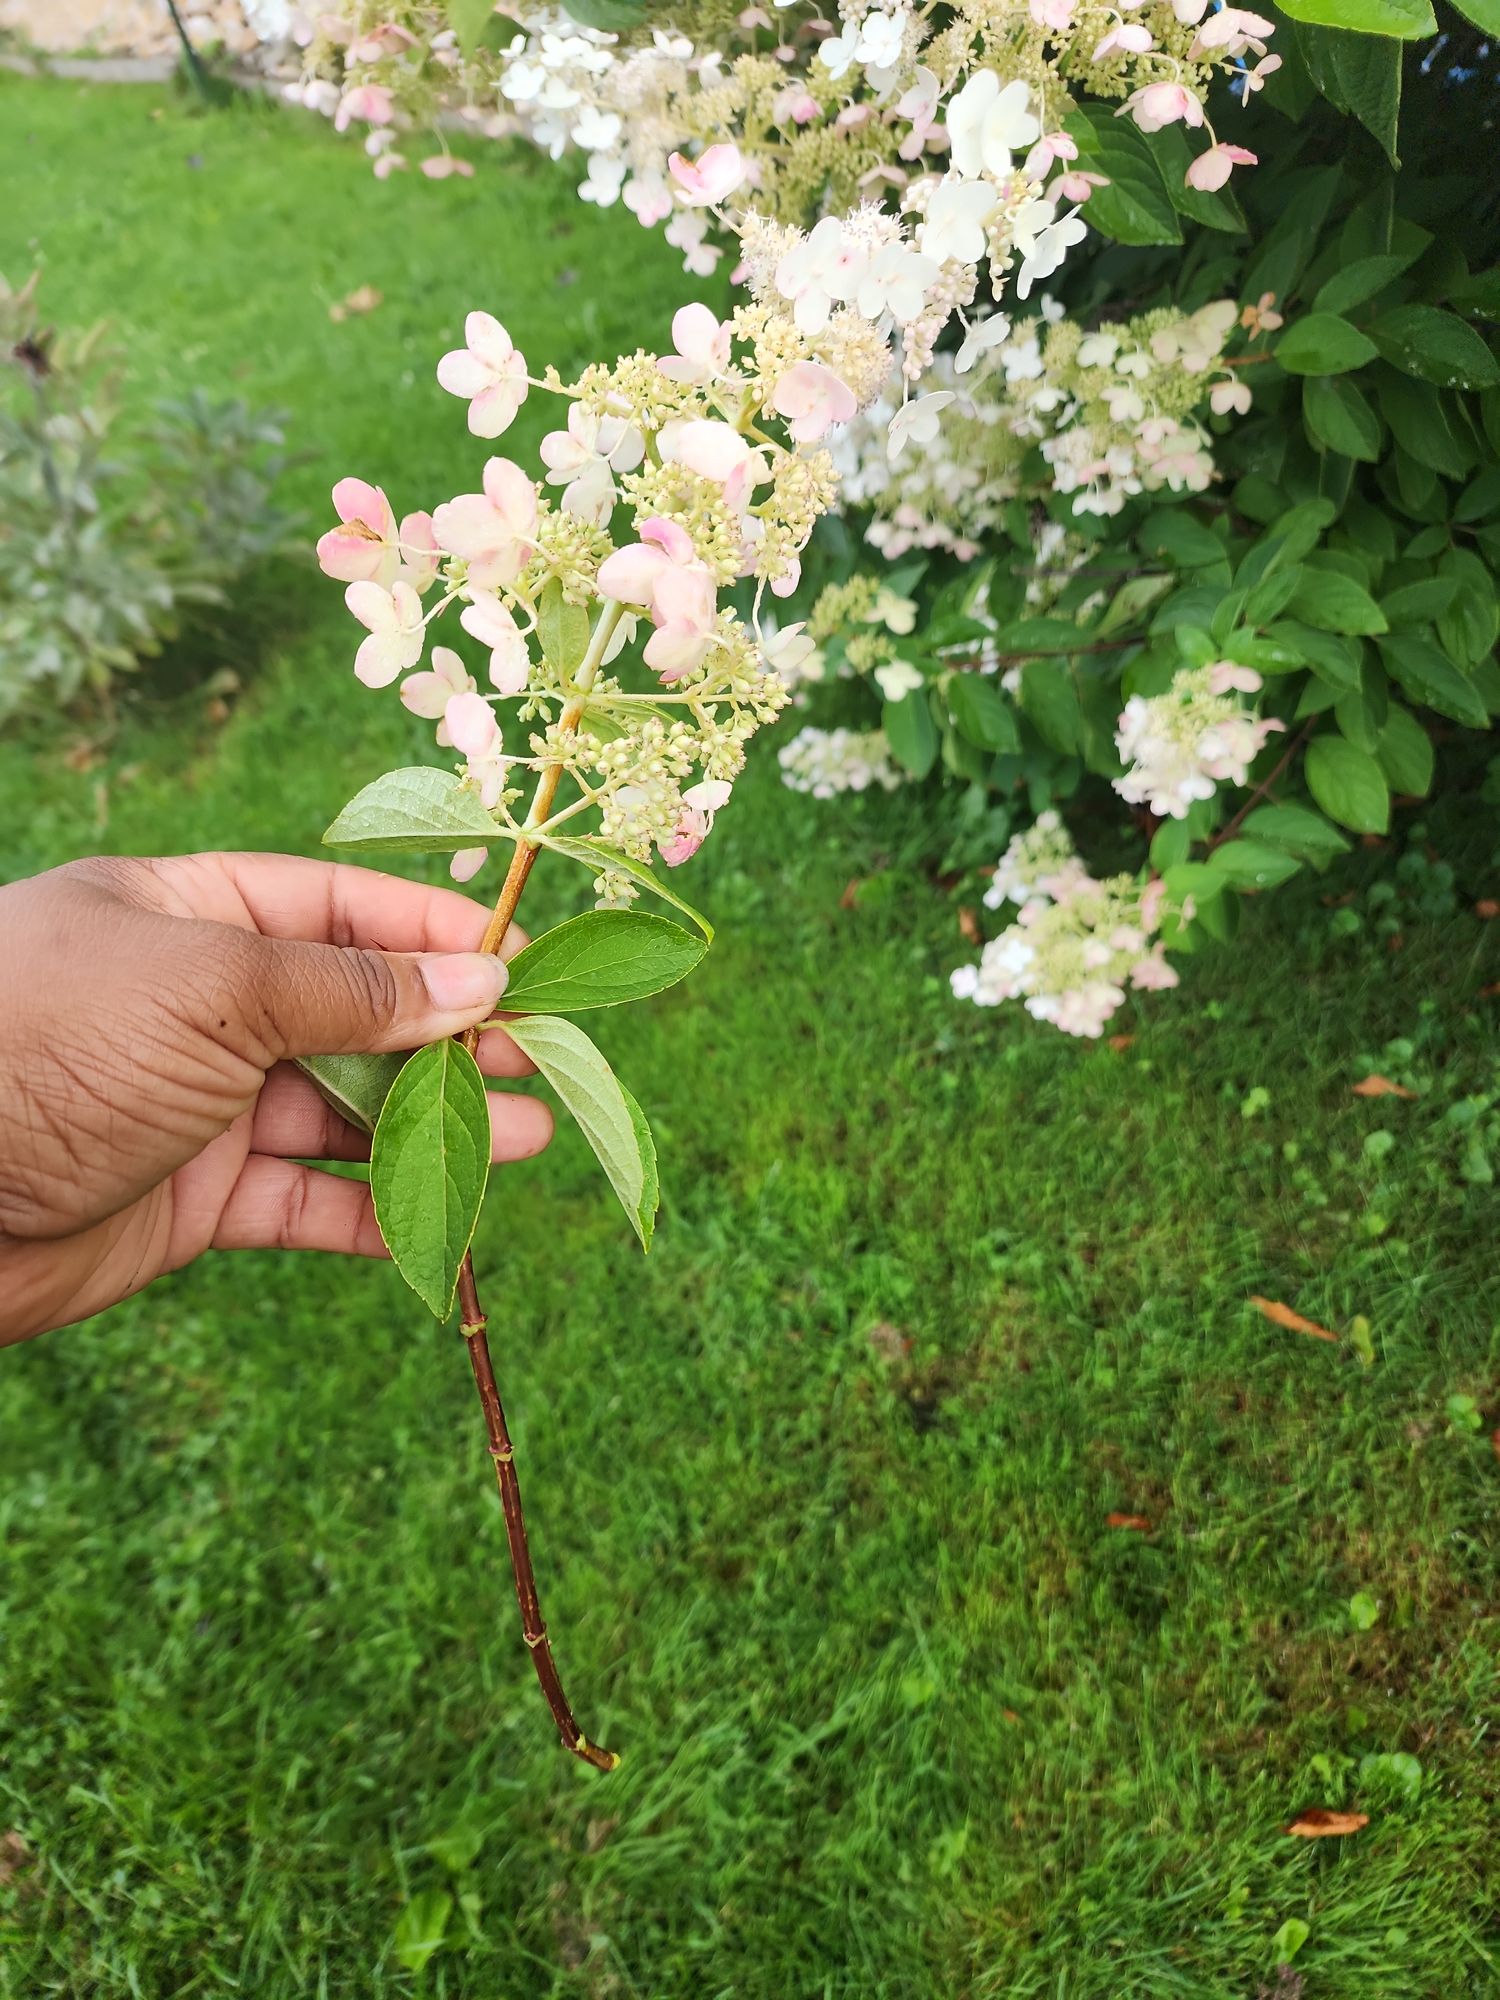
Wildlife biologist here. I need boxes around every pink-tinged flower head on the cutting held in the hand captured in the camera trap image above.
[308,272,892,884]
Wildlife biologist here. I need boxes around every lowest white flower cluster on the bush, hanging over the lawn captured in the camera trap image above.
[952,814,1178,1038]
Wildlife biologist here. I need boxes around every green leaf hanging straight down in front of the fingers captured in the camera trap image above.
[370,1042,490,1320]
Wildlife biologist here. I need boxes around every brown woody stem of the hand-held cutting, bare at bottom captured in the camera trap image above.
[446,604,622,1770]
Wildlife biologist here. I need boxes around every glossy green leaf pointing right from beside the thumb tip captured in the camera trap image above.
[504,910,708,1014]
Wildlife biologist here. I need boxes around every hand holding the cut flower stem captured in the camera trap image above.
[0,854,552,1344]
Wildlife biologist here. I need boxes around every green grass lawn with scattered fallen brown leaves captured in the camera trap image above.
[0,78,1500,2000]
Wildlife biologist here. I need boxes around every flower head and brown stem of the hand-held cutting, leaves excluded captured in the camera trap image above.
[318,152,1080,1736]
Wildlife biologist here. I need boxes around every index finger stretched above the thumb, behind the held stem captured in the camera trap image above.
[204,854,526,958]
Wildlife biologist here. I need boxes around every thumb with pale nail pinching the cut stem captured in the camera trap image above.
[236,934,506,1058]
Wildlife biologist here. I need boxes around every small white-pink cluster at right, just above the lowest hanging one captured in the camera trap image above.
[1114,660,1286,820]
